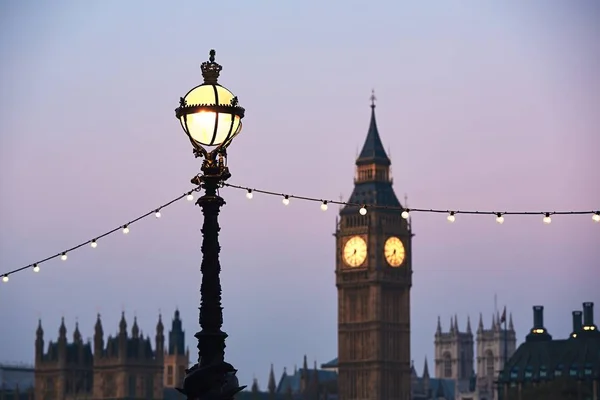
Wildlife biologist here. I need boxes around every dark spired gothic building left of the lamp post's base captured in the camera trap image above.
[34,311,189,400]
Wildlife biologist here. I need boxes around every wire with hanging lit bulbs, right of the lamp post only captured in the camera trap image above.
[223,183,600,220]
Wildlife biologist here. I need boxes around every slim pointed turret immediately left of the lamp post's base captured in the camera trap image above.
[164,310,190,388]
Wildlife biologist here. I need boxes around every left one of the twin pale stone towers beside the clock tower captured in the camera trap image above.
[435,315,475,381]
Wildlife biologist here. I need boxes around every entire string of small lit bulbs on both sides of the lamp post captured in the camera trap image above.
[0,183,600,282]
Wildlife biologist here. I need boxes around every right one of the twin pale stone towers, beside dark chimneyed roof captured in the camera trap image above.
[477,311,517,400]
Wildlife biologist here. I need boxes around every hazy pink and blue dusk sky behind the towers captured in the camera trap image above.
[0,0,600,387]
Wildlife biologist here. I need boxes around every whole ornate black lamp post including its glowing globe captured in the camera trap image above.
[175,50,246,400]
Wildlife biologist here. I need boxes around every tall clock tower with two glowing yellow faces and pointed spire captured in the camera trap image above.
[335,96,413,400]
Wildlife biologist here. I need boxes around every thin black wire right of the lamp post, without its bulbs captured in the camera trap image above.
[223,183,599,216]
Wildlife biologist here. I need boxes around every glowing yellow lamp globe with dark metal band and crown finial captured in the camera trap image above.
[175,50,244,148]
